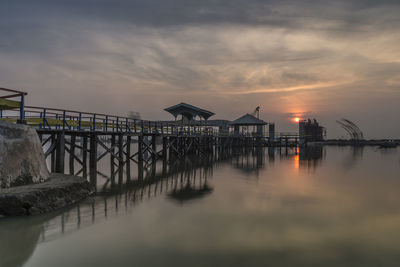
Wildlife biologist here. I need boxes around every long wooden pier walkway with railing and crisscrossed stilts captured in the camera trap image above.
[0,88,298,189]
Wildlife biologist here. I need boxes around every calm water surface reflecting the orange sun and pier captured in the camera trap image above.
[0,147,400,267]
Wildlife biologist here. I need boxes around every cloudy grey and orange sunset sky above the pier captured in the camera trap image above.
[0,0,400,138]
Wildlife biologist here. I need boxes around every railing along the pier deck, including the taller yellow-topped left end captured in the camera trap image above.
[0,88,288,138]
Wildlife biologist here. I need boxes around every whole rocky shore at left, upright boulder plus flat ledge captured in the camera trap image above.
[0,121,95,216]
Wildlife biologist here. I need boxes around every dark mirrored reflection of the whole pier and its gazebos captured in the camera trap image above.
[39,147,324,245]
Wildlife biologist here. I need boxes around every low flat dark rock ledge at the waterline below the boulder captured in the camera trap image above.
[0,173,95,216]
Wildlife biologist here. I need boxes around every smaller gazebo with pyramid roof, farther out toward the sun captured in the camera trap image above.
[231,114,268,136]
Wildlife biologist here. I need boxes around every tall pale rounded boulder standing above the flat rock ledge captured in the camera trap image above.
[0,121,49,188]
